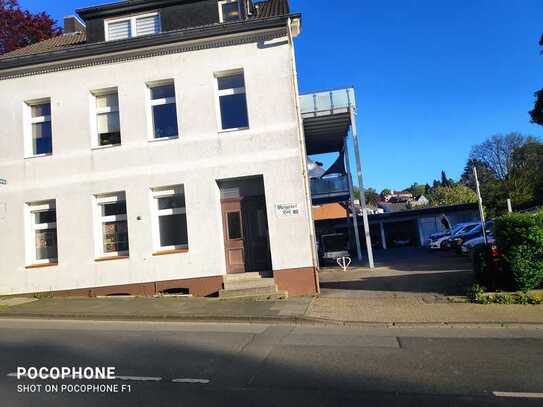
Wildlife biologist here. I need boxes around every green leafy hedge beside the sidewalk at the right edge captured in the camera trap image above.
[494,211,543,292]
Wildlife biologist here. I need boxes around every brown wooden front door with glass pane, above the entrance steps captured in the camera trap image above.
[221,199,245,274]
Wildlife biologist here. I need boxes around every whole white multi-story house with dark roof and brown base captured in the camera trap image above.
[0,0,370,296]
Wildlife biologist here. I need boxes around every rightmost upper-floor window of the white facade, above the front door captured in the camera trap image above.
[217,72,249,130]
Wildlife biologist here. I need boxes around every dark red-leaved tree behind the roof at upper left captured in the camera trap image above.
[0,0,62,54]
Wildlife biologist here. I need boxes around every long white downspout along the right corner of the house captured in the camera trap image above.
[287,18,320,293]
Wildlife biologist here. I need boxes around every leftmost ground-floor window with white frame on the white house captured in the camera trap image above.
[27,201,58,265]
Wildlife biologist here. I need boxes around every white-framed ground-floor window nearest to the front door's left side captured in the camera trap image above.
[152,185,189,251]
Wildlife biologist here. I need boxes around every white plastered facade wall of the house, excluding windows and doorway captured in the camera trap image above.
[0,30,314,294]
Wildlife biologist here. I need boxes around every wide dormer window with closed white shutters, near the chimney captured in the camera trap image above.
[105,12,160,41]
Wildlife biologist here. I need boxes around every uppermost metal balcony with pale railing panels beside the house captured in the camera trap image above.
[300,88,355,155]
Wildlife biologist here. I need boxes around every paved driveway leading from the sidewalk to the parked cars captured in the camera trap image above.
[320,248,473,301]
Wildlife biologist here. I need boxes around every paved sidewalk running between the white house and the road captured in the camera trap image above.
[0,296,543,328]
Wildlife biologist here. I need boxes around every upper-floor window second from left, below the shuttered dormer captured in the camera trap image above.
[94,90,121,147]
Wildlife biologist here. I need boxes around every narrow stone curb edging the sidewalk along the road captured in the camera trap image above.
[0,312,543,329]
